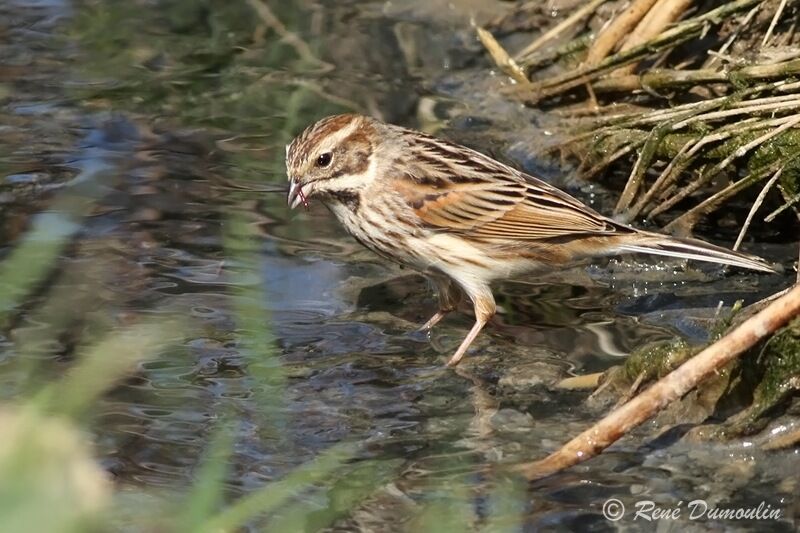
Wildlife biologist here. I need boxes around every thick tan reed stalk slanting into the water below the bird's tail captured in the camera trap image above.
[514,284,800,480]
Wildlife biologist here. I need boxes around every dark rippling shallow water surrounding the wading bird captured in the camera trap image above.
[0,0,797,531]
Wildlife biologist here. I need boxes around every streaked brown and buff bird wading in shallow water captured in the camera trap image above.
[286,114,775,366]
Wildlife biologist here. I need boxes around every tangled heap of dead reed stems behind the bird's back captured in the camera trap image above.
[479,0,800,234]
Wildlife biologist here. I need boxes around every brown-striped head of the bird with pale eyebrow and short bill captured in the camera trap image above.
[286,115,380,208]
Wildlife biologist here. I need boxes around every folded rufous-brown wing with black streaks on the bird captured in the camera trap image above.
[393,134,631,240]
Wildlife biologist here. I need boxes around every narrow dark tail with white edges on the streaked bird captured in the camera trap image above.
[617,232,777,273]
